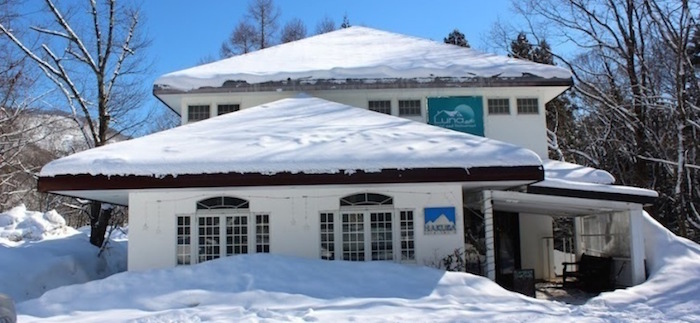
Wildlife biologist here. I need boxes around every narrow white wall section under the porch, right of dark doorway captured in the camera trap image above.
[520,213,552,279]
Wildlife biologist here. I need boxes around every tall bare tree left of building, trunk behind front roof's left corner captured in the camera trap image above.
[0,0,148,246]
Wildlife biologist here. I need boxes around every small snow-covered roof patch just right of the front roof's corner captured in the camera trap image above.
[542,159,615,184]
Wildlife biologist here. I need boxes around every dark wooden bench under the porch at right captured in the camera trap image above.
[562,253,613,293]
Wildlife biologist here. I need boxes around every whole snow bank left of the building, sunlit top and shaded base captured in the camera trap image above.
[0,205,127,302]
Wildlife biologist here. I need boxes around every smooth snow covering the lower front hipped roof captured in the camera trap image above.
[40,97,542,177]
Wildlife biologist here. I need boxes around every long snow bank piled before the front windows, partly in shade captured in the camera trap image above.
[18,254,568,322]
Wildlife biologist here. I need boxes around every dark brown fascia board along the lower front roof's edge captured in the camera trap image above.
[38,166,544,192]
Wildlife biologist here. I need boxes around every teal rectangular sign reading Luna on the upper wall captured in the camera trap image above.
[428,96,484,136]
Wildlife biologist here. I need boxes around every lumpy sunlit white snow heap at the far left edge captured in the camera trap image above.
[0,205,78,244]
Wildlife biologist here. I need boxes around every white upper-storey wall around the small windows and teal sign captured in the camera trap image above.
[175,86,566,157]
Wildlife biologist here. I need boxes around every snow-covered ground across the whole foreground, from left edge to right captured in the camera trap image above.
[0,209,700,322]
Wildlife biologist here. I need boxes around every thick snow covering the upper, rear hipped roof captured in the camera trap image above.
[155,26,571,91]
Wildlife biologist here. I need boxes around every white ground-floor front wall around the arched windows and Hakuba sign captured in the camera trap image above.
[128,184,464,271]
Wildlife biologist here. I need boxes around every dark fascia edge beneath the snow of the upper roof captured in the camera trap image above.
[153,76,574,96]
